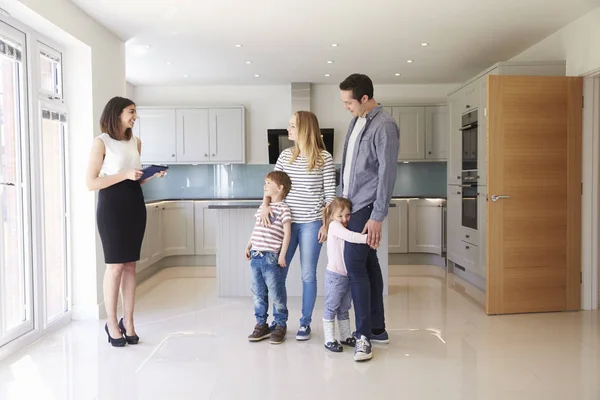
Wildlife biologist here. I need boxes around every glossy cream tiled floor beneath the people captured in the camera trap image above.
[0,267,600,400]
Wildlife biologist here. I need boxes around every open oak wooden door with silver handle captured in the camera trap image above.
[486,76,583,314]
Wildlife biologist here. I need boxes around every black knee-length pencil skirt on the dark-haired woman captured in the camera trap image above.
[96,179,146,264]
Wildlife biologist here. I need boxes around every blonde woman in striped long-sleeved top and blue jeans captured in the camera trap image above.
[261,111,336,340]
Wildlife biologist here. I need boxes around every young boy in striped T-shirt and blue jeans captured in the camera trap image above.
[246,171,292,344]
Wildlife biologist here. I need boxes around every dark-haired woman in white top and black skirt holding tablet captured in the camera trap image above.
[86,97,165,347]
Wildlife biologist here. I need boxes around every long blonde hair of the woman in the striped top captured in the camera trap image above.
[290,111,325,171]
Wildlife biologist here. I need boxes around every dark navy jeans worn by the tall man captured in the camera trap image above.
[344,205,385,338]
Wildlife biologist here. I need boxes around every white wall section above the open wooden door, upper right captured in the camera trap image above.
[513,7,600,76]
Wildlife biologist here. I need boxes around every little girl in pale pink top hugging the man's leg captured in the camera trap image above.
[323,197,367,353]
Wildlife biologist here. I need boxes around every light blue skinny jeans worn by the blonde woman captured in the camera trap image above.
[285,221,323,325]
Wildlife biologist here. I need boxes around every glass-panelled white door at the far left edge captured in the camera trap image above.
[0,23,33,346]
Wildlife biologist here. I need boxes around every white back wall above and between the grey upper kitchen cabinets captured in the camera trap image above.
[133,85,457,164]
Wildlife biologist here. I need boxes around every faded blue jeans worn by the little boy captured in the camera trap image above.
[250,250,288,326]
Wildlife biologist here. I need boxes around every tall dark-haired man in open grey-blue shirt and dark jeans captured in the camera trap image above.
[339,74,400,361]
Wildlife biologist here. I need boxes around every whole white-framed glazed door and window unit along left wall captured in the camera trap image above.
[0,17,70,361]
